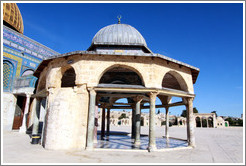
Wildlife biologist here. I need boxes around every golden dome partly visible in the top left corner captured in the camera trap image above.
[3,3,24,34]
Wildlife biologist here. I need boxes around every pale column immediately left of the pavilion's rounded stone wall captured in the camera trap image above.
[32,98,41,135]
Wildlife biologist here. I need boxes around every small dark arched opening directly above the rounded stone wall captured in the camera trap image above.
[61,67,76,88]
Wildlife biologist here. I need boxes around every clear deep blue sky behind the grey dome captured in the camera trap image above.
[18,3,243,117]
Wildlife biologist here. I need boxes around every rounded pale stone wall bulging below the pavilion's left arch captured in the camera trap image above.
[44,88,88,150]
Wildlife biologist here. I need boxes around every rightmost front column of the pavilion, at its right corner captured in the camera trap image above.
[186,98,195,147]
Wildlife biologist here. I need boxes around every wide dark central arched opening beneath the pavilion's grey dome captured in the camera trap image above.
[99,66,144,86]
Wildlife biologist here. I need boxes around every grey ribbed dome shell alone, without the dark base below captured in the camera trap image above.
[92,24,147,47]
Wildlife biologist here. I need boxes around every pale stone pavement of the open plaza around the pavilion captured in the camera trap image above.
[1,126,245,164]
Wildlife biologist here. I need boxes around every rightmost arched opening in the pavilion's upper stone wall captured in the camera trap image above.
[162,70,188,92]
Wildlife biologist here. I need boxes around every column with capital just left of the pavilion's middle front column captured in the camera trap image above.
[134,96,143,145]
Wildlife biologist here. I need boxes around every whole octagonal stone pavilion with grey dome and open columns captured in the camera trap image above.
[32,21,200,151]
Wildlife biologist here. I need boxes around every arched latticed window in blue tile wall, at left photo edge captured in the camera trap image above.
[3,61,14,90]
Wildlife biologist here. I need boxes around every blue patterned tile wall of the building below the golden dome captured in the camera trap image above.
[3,26,59,92]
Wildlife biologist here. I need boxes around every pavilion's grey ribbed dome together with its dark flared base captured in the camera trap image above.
[88,22,151,53]
